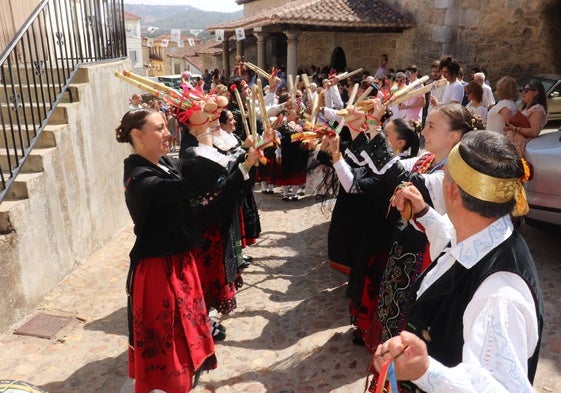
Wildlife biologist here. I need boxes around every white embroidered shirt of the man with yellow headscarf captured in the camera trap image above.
[412,209,539,393]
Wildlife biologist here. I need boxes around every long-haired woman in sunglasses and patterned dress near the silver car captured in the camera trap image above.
[504,79,547,156]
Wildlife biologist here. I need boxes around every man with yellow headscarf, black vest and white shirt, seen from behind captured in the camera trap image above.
[373,131,544,393]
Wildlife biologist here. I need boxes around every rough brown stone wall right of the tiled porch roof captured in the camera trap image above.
[390,0,561,83]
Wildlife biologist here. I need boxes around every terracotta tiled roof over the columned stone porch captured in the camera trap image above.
[207,0,415,32]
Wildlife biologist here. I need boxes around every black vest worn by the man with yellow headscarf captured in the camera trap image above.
[407,231,543,382]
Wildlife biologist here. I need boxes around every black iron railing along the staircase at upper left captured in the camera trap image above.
[0,0,127,202]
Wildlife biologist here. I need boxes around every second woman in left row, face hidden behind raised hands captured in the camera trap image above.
[178,102,258,340]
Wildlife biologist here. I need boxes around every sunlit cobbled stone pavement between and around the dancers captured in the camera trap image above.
[0,192,561,393]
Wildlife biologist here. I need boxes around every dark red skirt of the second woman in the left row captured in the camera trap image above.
[192,228,237,314]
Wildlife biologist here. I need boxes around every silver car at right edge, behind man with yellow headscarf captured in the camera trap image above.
[525,129,561,225]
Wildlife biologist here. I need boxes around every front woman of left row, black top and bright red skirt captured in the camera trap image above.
[116,109,257,393]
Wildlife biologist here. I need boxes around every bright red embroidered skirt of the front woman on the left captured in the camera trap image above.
[129,253,217,393]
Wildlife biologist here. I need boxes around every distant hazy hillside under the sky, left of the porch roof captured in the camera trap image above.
[125,4,243,39]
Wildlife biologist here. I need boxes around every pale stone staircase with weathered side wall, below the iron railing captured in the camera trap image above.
[0,60,132,332]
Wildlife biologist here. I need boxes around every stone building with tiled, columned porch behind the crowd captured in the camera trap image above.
[208,0,561,82]
